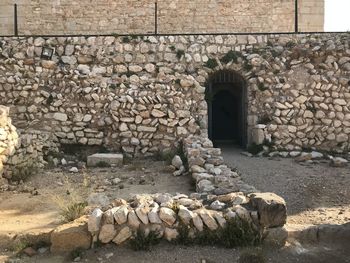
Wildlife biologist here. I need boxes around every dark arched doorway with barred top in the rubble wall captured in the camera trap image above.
[206,70,247,147]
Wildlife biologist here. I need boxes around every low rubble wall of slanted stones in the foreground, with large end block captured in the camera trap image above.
[82,193,287,252]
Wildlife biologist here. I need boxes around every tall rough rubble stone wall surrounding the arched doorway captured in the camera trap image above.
[0,34,350,156]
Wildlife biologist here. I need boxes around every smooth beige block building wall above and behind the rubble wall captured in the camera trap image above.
[0,0,324,35]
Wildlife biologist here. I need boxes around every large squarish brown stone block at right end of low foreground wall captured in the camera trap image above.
[249,193,287,227]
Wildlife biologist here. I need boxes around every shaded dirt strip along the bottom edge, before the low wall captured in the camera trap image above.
[0,242,350,263]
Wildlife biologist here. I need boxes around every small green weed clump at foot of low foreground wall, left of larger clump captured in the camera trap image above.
[130,229,160,251]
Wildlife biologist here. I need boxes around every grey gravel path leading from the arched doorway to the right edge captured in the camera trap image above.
[221,146,350,224]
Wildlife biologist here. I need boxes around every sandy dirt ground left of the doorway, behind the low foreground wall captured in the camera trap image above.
[0,160,193,251]
